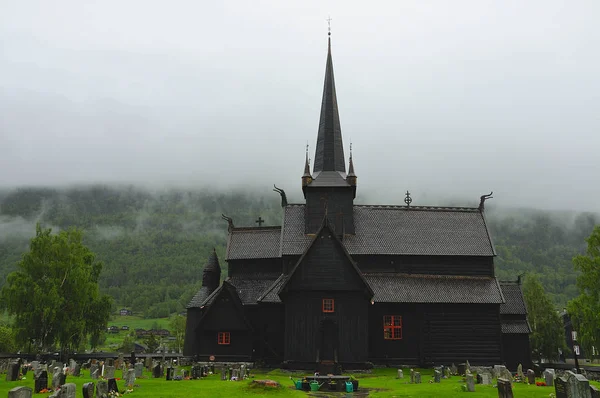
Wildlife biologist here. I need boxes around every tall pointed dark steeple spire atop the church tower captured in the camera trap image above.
[313,37,346,177]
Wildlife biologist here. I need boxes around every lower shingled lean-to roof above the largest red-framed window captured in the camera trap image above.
[365,273,504,304]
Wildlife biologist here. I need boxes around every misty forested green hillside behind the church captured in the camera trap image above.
[0,185,600,317]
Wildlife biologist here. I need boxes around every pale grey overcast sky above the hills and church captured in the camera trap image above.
[0,0,600,211]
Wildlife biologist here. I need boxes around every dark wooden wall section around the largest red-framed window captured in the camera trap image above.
[369,303,423,365]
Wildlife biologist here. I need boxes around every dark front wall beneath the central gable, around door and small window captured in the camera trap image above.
[285,291,370,363]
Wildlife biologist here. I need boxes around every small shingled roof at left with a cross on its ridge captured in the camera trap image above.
[227,227,281,260]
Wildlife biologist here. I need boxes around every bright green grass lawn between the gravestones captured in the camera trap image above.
[0,368,600,398]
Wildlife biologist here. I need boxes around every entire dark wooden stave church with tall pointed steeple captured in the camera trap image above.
[184,33,531,369]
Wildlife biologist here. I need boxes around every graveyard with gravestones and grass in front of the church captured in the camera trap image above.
[0,363,600,398]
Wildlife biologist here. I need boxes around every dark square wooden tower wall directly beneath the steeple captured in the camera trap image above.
[304,187,354,234]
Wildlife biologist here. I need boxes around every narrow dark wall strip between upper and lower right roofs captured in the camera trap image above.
[352,255,494,276]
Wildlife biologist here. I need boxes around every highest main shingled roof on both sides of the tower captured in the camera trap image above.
[281,204,495,256]
